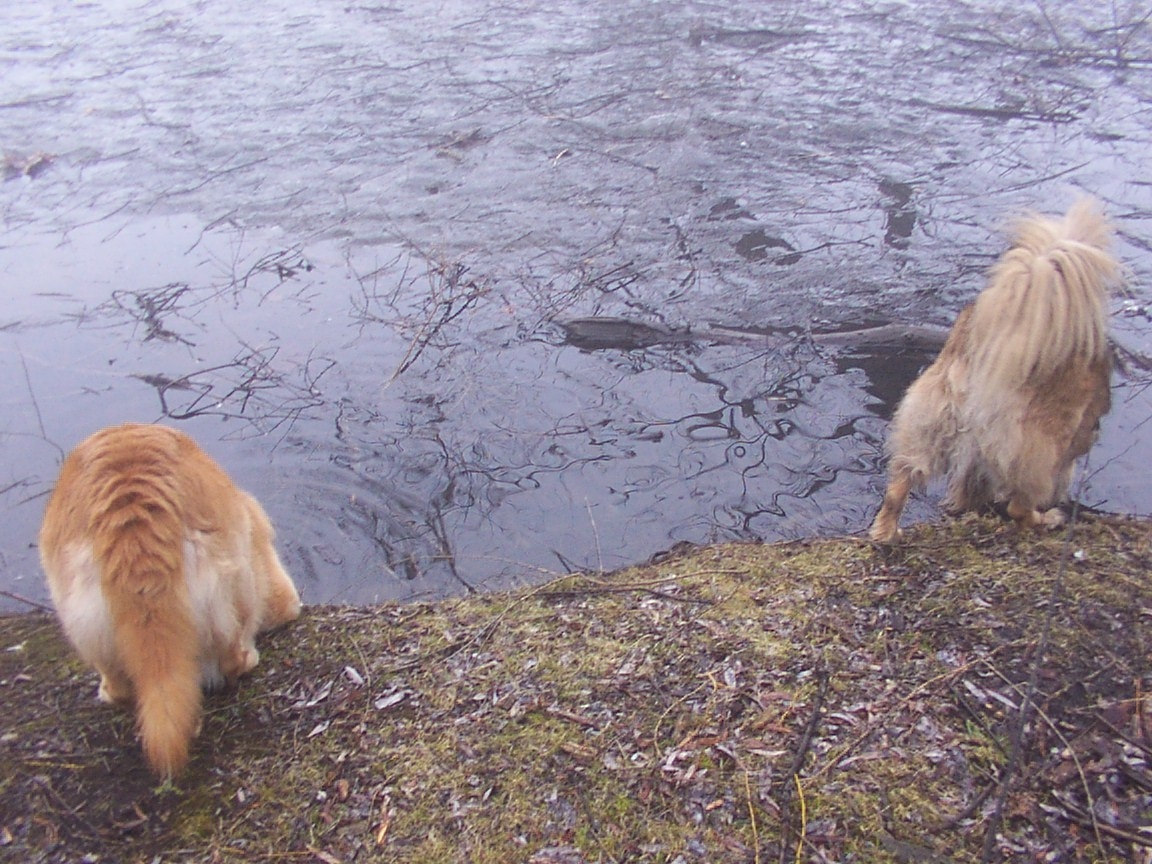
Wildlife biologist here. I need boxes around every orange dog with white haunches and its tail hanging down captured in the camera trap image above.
[40,424,300,778]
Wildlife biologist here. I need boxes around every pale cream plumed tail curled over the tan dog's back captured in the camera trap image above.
[969,198,1120,393]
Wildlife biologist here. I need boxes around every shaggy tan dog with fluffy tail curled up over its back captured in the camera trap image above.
[871,199,1120,543]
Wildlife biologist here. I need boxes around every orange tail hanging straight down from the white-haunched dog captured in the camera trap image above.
[91,463,202,778]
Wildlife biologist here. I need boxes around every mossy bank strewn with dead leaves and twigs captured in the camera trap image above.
[0,517,1152,864]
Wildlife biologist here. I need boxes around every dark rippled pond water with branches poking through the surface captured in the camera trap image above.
[0,0,1152,608]
